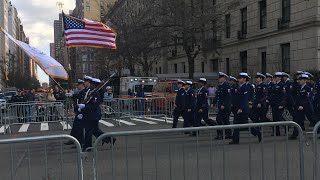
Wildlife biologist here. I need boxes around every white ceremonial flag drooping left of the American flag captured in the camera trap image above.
[0,27,69,80]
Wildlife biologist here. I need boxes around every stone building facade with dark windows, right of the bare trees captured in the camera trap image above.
[219,0,320,75]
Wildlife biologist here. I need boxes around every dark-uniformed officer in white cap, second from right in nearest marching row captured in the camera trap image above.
[268,72,286,136]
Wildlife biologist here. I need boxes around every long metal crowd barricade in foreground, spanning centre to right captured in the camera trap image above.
[93,121,305,180]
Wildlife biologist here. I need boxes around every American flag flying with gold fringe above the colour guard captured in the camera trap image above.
[63,15,117,49]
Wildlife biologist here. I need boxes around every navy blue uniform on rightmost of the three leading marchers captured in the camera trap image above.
[194,86,215,127]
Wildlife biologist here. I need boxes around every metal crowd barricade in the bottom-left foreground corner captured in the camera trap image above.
[0,135,83,180]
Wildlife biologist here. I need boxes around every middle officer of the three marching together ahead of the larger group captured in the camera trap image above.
[184,81,196,127]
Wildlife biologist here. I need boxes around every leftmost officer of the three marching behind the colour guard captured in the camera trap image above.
[172,79,187,128]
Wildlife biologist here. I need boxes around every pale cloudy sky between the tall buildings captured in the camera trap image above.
[11,0,75,82]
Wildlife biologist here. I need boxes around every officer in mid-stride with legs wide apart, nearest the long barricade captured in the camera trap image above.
[229,73,261,144]
